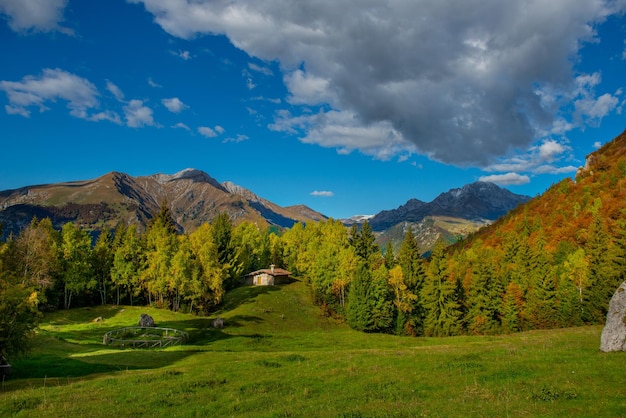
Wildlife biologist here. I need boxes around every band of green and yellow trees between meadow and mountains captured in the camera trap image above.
[0,202,626,352]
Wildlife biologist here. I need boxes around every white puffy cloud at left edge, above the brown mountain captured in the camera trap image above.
[0,68,99,119]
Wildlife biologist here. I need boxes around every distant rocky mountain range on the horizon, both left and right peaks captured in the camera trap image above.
[0,169,529,251]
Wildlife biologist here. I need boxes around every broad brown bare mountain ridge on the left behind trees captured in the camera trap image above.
[0,169,326,235]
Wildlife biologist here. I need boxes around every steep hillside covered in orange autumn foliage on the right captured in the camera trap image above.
[450,131,626,252]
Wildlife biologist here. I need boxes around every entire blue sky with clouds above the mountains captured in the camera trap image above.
[0,0,626,219]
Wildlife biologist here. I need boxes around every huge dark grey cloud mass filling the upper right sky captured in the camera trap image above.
[129,0,626,166]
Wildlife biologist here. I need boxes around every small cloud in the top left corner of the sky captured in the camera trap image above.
[0,0,72,34]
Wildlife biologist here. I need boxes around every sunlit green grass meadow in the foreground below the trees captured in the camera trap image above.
[0,281,626,417]
